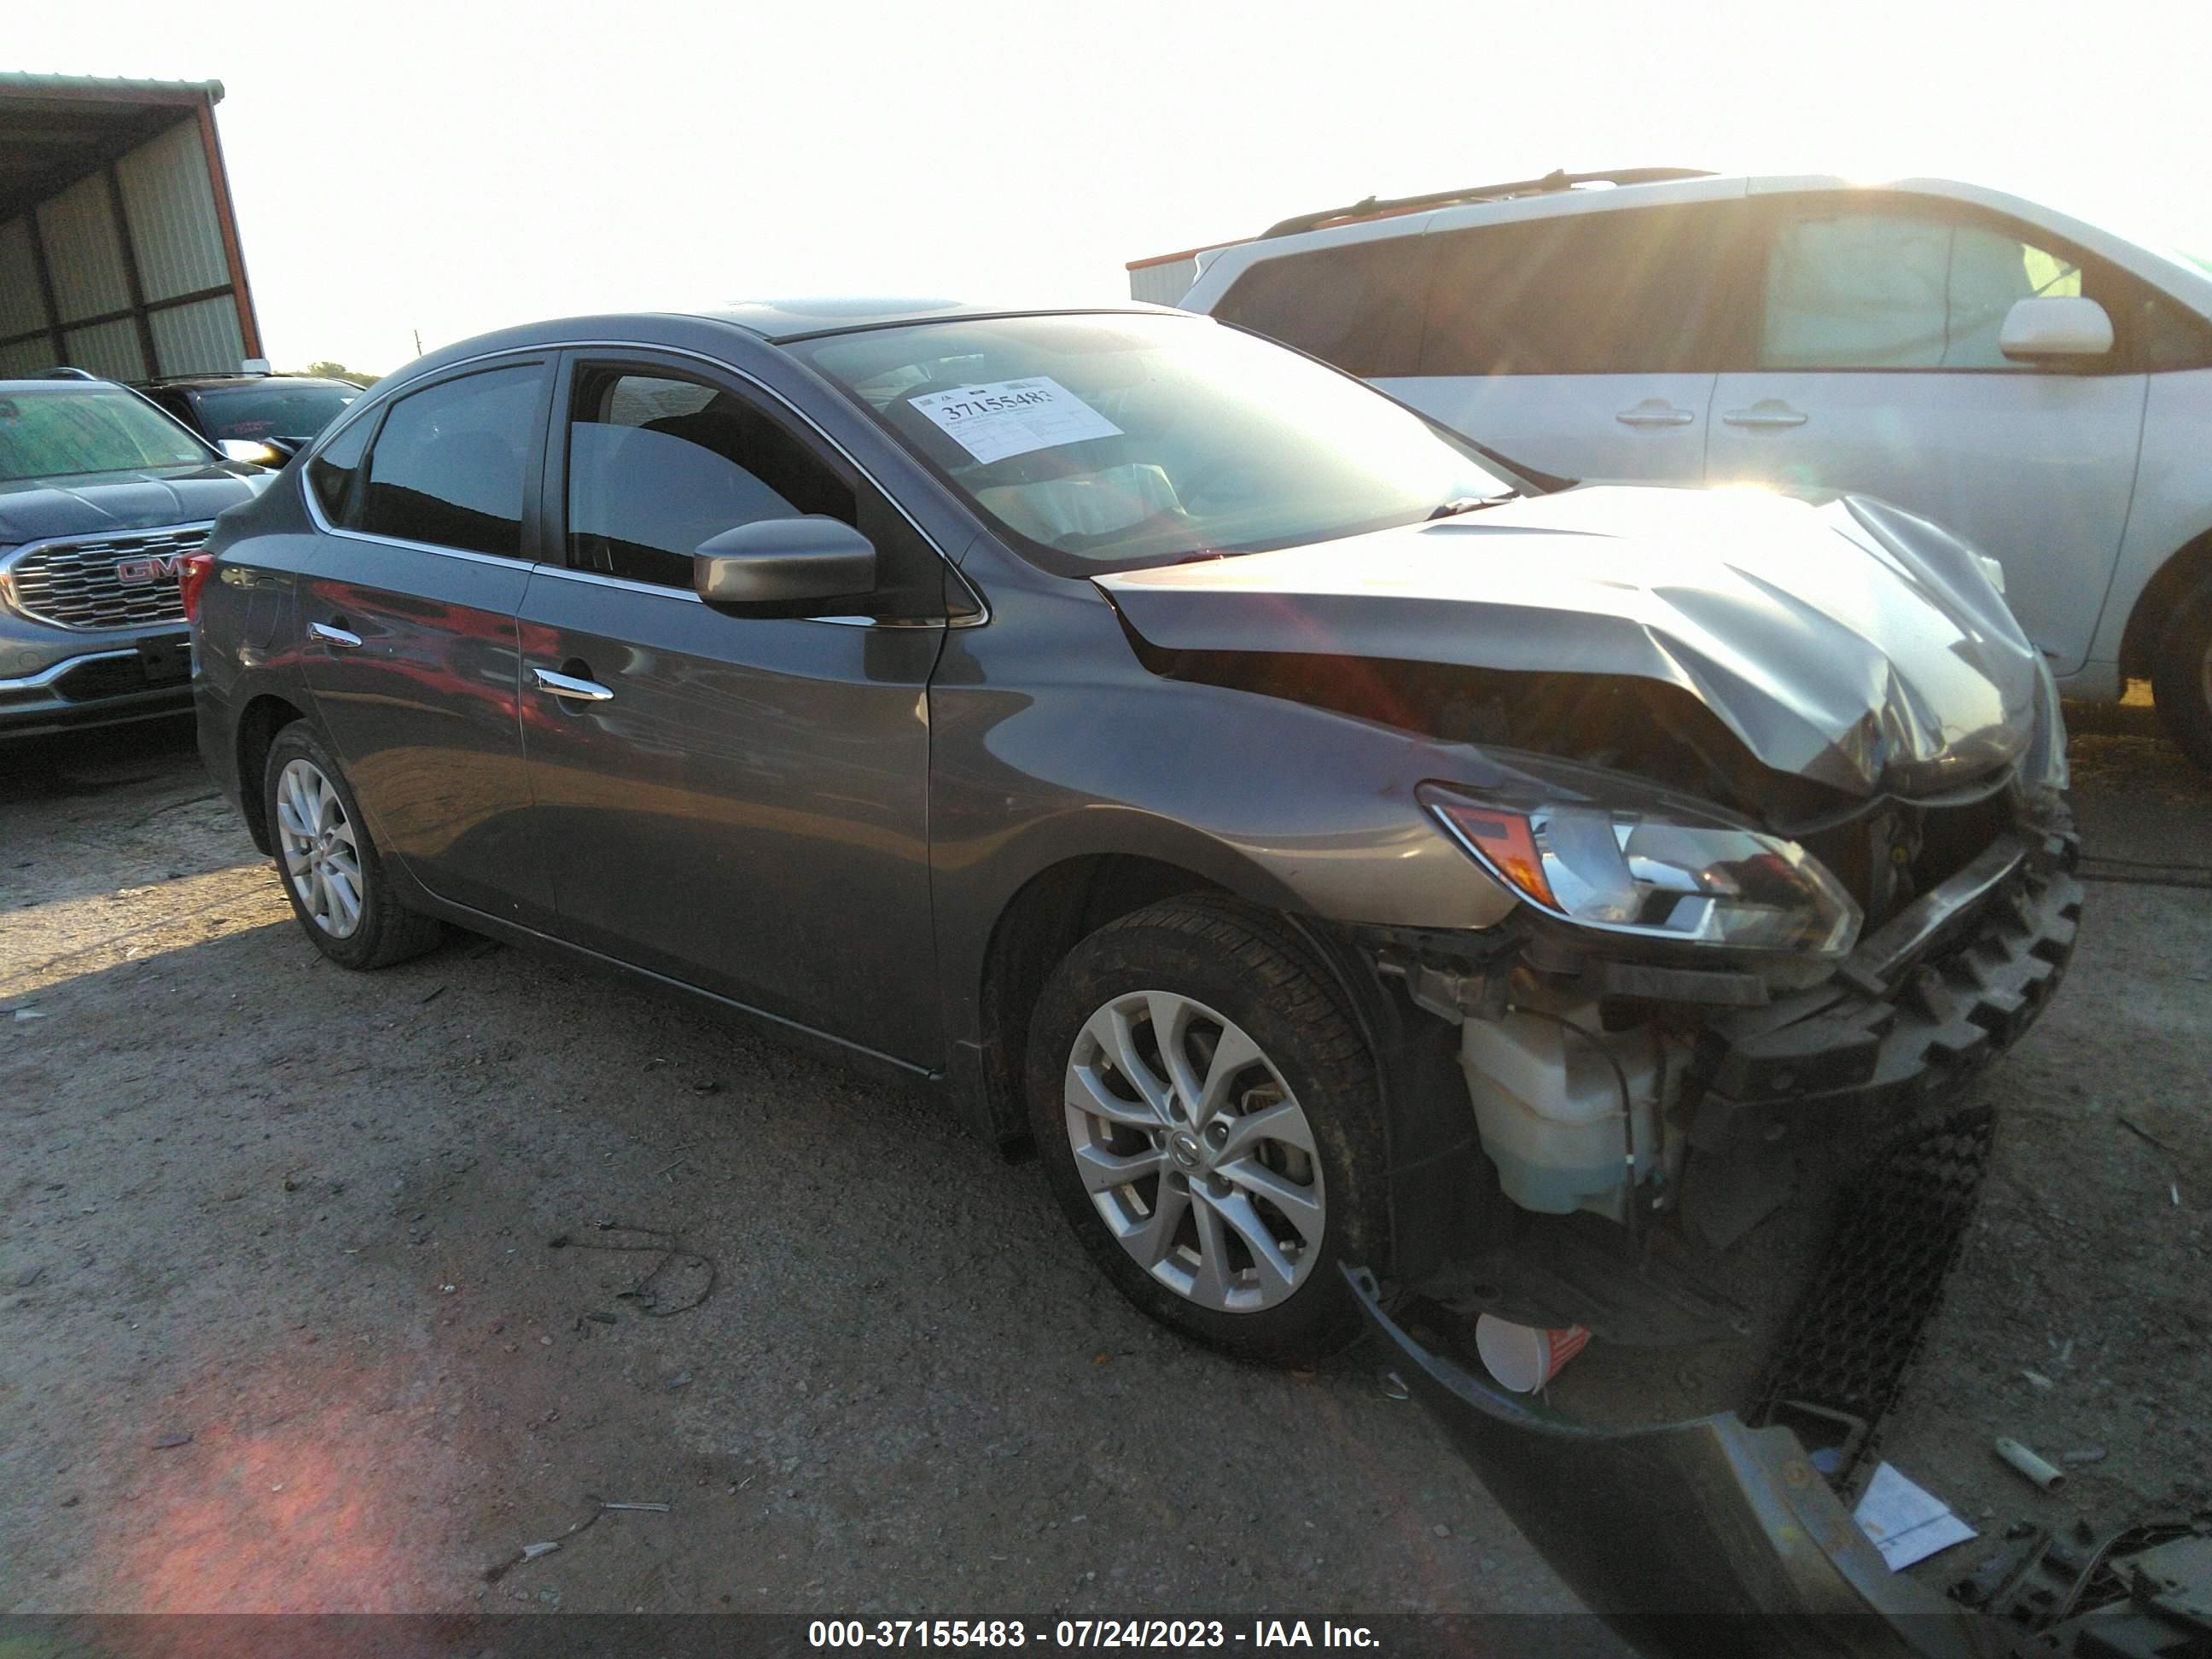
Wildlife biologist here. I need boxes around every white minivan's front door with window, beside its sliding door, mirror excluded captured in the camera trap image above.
[1708,193,2148,675]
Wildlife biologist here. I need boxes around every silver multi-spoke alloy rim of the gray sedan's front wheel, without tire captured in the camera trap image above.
[1064,991,1325,1314]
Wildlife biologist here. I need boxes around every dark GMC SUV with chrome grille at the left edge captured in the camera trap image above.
[0,376,274,739]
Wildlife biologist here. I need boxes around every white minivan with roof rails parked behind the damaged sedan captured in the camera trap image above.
[1167,168,2212,765]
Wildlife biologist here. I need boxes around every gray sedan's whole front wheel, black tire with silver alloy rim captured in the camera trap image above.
[1028,898,1389,1365]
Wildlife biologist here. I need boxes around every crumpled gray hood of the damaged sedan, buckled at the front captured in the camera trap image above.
[1097,485,2041,796]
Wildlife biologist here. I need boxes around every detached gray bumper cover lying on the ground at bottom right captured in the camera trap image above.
[1342,1267,2212,1659]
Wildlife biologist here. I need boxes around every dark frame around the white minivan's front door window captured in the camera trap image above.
[1727,190,2155,378]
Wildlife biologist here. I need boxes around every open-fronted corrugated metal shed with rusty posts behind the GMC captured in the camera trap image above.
[0,73,261,381]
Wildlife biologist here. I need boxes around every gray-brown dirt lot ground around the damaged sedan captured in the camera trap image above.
[0,707,2212,1615]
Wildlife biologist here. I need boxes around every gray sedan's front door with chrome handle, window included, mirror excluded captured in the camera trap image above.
[522,354,945,1066]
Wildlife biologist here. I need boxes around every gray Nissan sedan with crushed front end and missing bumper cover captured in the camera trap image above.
[183,303,2079,1360]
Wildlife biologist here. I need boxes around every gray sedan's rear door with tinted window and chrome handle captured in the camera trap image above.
[301,356,553,927]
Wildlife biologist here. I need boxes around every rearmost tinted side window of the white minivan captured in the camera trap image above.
[1212,235,1431,378]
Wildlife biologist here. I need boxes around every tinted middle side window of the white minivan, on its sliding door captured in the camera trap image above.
[1420,203,1741,374]
